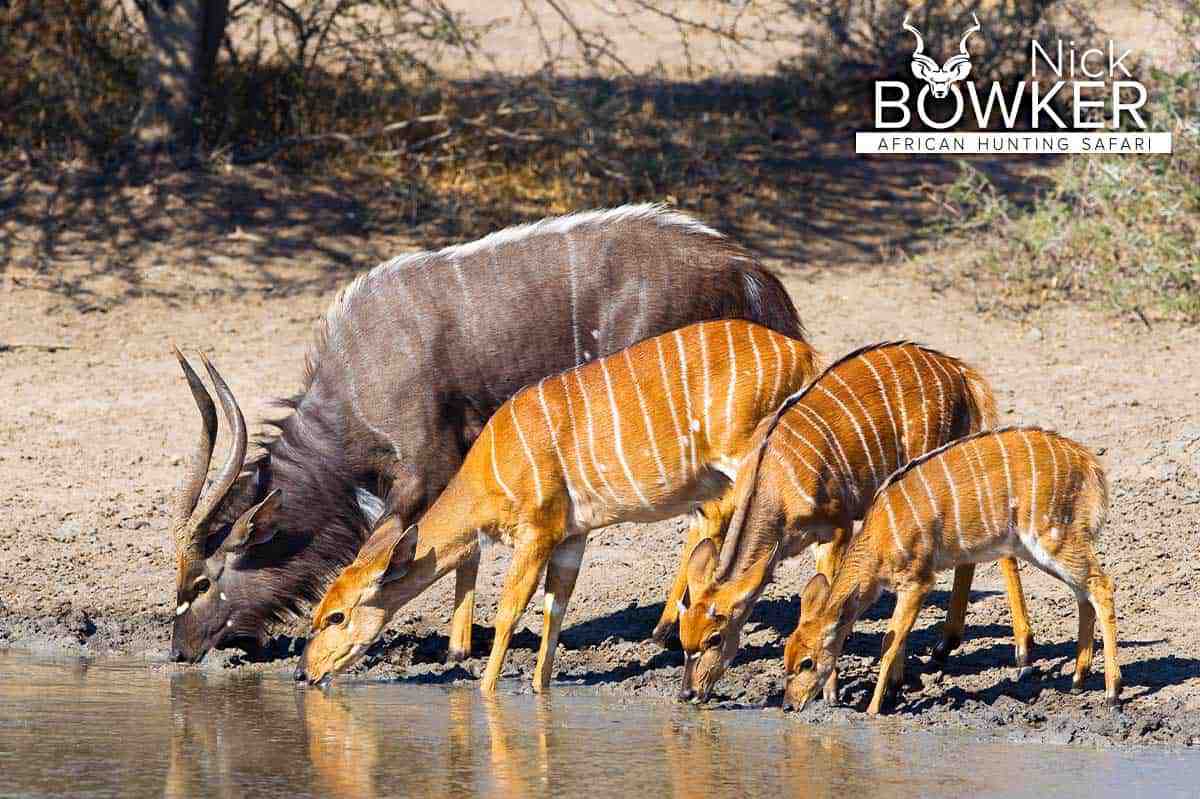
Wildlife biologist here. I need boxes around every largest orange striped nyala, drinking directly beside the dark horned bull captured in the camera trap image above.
[301,322,816,691]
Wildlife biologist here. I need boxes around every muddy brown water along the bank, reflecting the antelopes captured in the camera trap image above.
[0,651,1200,799]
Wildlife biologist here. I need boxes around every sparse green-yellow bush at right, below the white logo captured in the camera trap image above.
[931,48,1200,316]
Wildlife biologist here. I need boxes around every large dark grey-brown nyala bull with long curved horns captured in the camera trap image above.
[170,205,804,662]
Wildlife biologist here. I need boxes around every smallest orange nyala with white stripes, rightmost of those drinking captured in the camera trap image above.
[784,427,1121,714]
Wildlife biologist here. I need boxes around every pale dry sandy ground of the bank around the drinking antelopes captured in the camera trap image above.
[0,167,1200,745]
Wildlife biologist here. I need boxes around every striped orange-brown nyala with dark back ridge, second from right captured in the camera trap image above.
[679,342,1032,702]
